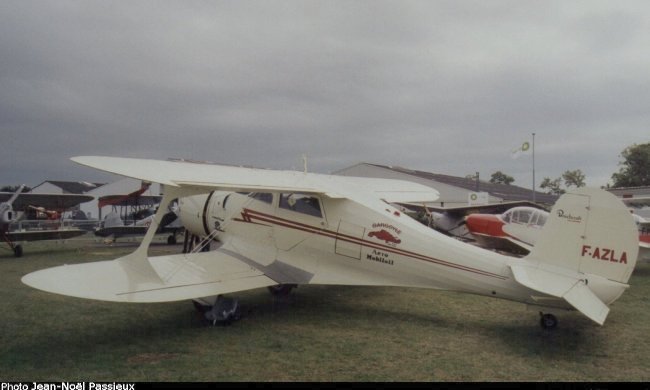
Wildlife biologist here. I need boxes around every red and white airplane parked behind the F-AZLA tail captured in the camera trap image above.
[465,207,650,261]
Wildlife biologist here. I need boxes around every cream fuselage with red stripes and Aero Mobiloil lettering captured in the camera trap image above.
[180,192,567,307]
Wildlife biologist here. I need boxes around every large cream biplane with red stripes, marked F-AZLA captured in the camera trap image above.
[22,157,638,328]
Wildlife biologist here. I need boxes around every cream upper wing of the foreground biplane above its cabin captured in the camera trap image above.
[72,157,439,203]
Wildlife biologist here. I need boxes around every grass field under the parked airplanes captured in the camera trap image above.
[0,236,650,381]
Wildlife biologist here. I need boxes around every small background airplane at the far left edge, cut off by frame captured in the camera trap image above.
[0,186,93,257]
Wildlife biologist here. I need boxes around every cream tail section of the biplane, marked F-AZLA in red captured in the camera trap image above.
[511,189,639,325]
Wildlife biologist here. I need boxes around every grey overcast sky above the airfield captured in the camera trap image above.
[0,0,650,187]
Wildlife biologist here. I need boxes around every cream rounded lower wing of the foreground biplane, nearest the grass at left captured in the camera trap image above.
[22,250,277,302]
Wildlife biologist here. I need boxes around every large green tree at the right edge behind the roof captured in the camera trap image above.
[612,142,650,187]
